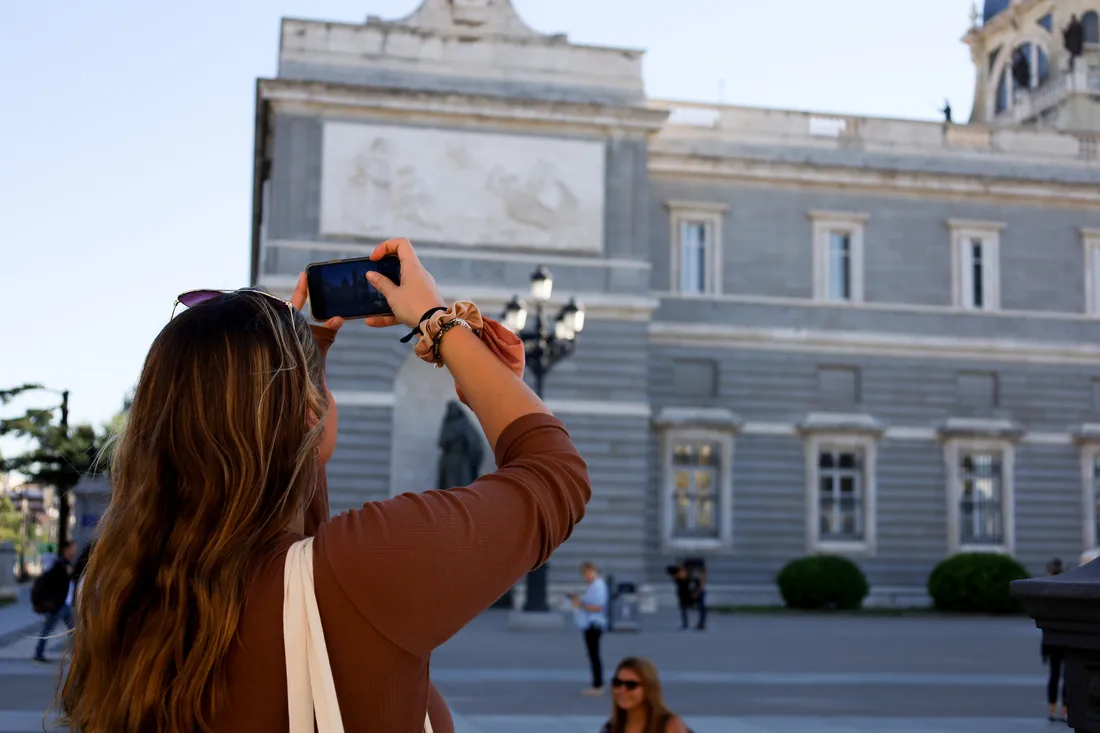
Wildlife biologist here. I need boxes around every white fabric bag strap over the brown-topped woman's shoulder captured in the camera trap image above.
[283,537,433,733]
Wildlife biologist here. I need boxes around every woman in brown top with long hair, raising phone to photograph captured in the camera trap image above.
[61,240,591,733]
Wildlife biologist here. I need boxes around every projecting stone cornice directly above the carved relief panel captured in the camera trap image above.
[260,79,668,134]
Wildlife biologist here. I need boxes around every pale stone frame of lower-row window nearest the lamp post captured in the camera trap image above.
[658,411,739,551]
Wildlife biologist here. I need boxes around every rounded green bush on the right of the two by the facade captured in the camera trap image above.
[928,553,1031,613]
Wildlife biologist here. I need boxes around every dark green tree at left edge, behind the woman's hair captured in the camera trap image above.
[0,384,105,540]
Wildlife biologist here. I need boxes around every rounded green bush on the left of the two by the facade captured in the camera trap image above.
[776,555,871,610]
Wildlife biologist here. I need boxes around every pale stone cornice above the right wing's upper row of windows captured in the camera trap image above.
[649,150,1100,208]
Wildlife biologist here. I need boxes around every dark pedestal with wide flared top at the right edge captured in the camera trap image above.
[1012,560,1100,733]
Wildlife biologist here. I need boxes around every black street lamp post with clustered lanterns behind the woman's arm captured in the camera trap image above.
[503,265,584,613]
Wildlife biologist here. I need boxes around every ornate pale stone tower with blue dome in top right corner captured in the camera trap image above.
[963,0,1100,131]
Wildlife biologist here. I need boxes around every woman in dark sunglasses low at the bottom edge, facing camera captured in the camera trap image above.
[600,657,691,733]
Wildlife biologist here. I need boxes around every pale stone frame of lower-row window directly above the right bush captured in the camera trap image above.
[944,437,1016,555]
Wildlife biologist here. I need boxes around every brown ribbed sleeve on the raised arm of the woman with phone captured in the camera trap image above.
[315,414,592,656]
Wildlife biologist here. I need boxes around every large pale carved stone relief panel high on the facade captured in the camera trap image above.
[321,122,605,253]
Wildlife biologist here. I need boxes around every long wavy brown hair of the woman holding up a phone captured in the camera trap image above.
[59,291,328,733]
